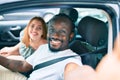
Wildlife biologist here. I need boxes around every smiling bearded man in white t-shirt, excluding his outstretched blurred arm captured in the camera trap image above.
[0,14,82,80]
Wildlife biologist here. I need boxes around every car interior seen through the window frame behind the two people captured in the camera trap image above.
[0,8,108,68]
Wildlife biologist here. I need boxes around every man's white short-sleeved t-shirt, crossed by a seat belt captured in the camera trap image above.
[26,44,82,80]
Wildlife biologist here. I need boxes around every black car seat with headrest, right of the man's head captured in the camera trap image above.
[70,16,108,68]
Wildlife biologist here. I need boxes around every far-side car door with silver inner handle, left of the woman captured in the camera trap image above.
[0,13,26,49]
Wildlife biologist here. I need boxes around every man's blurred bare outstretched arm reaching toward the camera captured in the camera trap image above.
[64,35,120,80]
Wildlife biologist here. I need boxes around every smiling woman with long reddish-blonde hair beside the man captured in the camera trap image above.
[0,17,47,59]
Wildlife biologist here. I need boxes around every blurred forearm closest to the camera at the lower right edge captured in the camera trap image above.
[96,35,120,80]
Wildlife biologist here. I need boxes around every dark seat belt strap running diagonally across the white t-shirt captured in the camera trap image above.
[33,55,79,70]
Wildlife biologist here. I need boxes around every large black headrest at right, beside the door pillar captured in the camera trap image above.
[78,16,108,47]
